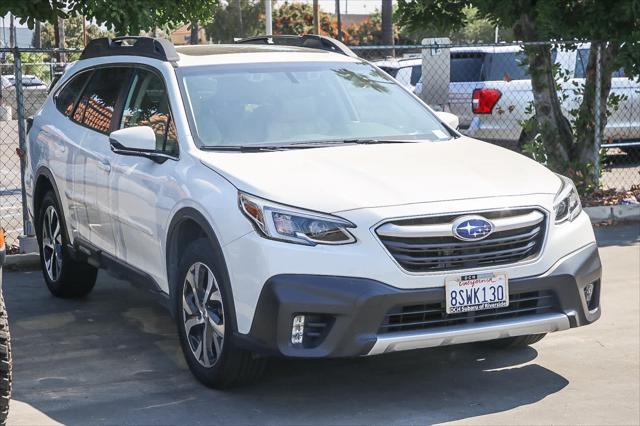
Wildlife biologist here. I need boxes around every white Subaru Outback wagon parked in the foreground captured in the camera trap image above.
[25,36,601,387]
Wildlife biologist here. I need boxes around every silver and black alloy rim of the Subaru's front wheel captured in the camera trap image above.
[182,262,225,368]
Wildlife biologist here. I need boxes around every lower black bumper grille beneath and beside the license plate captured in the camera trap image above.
[379,290,559,334]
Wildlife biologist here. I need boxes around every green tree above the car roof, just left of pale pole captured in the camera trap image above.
[205,0,264,43]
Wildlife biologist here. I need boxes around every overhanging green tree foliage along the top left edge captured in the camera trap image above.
[0,0,218,34]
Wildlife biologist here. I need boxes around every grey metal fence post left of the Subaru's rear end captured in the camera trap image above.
[13,46,36,253]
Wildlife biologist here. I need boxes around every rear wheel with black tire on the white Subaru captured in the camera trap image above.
[36,191,98,298]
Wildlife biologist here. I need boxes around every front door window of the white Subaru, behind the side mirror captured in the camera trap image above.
[120,69,178,154]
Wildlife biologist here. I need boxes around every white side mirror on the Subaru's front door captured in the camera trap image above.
[109,126,173,163]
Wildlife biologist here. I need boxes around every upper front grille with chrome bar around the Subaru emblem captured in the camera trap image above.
[376,209,546,272]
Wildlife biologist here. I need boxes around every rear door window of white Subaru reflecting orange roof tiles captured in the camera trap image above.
[73,67,131,133]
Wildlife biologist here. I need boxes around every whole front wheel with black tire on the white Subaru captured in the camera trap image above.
[172,238,266,389]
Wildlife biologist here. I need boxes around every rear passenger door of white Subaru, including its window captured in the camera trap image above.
[73,67,131,255]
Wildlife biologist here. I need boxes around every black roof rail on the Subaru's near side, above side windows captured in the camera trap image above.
[80,36,180,62]
